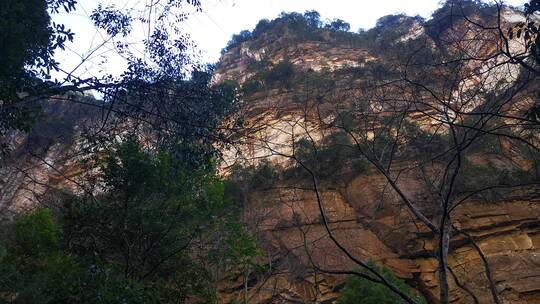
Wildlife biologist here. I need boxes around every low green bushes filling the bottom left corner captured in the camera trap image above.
[0,208,162,303]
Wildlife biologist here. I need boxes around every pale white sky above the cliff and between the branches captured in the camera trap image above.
[54,0,527,79]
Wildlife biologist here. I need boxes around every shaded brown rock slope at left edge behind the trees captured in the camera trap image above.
[0,101,99,219]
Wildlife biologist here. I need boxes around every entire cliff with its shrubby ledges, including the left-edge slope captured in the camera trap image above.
[0,2,540,304]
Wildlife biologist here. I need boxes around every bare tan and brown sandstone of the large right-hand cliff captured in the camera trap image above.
[215,7,540,303]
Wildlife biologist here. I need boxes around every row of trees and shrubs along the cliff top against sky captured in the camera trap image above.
[222,0,497,54]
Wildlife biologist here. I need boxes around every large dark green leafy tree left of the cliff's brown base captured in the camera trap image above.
[60,141,234,298]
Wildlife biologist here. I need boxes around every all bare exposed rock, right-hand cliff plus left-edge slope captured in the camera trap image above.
[0,2,540,304]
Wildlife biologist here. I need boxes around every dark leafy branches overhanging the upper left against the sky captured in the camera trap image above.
[0,0,215,162]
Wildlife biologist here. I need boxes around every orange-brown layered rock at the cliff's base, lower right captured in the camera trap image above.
[219,174,540,303]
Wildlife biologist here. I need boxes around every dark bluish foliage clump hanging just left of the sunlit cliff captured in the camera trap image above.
[117,67,239,163]
